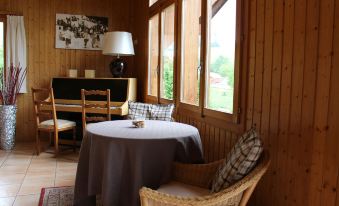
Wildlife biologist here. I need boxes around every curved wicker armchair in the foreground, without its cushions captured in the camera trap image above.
[139,151,270,206]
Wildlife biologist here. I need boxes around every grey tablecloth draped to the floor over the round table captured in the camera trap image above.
[74,120,203,206]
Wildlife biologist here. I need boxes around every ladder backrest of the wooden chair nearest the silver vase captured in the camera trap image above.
[31,88,58,131]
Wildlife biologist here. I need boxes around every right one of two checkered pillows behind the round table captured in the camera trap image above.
[151,104,174,121]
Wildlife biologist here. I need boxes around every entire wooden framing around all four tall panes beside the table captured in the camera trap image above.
[145,0,248,125]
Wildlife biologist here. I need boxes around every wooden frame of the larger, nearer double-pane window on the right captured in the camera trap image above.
[176,0,244,124]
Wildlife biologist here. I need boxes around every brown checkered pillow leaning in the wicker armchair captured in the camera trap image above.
[211,129,263,192]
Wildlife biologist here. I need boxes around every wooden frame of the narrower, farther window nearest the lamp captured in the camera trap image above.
[146,0,178,104]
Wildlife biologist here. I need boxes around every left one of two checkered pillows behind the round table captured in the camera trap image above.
[127,102,152,120]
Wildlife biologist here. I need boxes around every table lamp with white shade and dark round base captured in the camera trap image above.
[102,31,134,77]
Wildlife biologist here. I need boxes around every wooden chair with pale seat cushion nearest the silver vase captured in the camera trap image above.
[32,88,76,156]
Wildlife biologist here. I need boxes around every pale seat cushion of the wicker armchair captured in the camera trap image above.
[157,181,211,197]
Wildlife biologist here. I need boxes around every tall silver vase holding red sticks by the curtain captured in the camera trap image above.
[0,65,26,150]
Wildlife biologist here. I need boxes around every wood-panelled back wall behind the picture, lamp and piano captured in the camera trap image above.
[0,0,133,141]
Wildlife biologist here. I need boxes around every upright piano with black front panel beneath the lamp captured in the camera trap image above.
[46,77,137,116]
